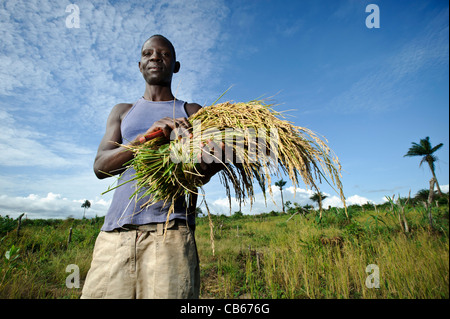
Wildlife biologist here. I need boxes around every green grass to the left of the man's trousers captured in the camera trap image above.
[0,217,103,299]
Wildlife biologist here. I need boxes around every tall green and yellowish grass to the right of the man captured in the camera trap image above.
[197,210,449,299]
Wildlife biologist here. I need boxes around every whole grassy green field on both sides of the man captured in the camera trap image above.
[0,205,449,299]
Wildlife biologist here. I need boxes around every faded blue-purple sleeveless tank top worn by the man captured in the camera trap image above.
[102,98,195,231]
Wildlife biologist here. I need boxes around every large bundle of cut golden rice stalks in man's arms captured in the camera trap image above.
[118,100,345,252]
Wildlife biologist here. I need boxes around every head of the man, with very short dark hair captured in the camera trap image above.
[139,36,180,86]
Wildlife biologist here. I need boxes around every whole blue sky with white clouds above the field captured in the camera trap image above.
[0,0,449,218]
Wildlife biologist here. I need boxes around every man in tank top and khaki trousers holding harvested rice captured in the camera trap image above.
[81,35,221,298]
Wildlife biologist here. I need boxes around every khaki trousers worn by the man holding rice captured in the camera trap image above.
[81,220,200,299]
